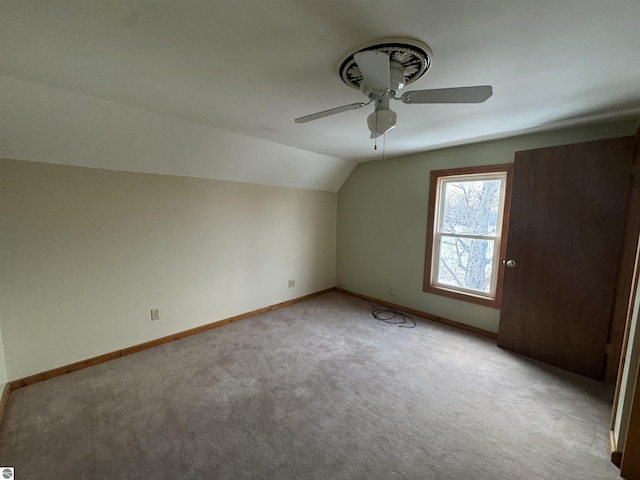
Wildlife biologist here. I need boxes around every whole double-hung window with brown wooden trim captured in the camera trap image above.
[423,164,512,308]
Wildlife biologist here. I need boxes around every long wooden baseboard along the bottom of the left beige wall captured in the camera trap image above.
[7,288,335,392]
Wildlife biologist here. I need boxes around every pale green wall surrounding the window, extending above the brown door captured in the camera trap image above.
[336,121,638,332]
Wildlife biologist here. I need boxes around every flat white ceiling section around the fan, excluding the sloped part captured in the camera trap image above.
[0,0,640,188]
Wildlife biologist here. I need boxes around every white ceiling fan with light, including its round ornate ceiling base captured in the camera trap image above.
[295,38,493,138]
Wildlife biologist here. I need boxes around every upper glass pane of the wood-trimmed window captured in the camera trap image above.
[439,179,502,235]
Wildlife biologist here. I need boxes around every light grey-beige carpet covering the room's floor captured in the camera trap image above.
[0,292,619,480]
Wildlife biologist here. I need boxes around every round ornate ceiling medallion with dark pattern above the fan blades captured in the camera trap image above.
[338,38,433,92]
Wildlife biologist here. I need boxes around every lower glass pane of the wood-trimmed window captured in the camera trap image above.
[436,235,494,293]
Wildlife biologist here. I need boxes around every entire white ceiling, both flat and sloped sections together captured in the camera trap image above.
[0,0,640,191]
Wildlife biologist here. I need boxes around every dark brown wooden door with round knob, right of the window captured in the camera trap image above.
[498,137,634,379]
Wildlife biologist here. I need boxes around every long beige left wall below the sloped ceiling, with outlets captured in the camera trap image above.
[0,160,337,380]
